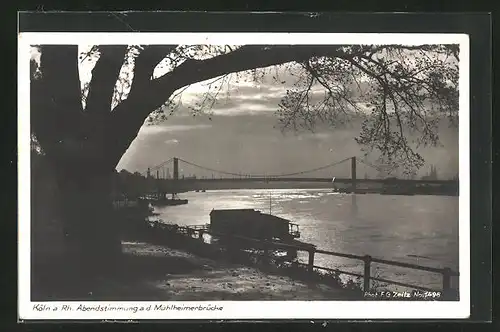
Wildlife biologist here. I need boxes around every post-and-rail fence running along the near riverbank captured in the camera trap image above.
[151,225,459,295]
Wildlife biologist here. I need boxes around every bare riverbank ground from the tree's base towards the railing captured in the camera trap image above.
[32,242,360,301]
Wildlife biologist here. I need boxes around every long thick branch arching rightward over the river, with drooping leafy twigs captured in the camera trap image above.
[105,45,458,171]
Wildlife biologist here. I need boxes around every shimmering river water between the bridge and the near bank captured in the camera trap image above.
[151,189,459,290]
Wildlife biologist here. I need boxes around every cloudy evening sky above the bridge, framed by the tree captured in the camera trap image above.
[32,46,458,178]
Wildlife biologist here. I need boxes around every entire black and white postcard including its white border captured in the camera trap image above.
[18,32,470,319]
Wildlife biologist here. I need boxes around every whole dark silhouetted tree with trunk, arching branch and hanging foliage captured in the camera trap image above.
[30,45,458,274]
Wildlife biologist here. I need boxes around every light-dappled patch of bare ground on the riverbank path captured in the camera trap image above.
[124,242,362,301]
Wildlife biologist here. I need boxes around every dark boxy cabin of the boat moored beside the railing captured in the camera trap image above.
[210,209,300,240]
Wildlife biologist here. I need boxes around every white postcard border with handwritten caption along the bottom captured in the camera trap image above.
[18,32,470,320]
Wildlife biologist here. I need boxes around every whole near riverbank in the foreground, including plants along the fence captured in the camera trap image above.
[32,208,458,301]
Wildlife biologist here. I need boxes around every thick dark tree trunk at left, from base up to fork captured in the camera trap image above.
[30,45,133,295]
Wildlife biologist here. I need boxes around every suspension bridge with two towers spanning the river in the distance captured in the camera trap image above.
[142,156,458,195]
